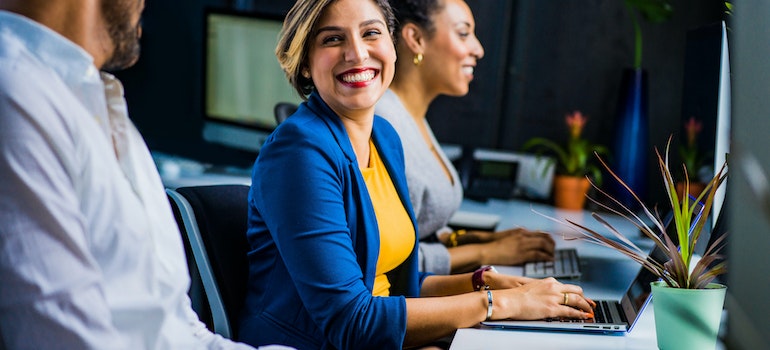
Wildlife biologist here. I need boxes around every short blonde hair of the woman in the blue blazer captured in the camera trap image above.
[275,0,396,99]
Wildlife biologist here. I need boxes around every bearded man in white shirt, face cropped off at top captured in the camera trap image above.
[0,0,284,349]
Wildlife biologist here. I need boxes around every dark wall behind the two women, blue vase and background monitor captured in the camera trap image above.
[118,0,729,208]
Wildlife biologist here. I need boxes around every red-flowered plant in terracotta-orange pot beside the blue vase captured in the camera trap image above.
[523,111,608,210]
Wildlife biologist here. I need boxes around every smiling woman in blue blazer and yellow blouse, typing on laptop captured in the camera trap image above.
[239,0,591,349]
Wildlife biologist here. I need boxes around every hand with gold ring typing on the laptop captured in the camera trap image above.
[492,277,596,320]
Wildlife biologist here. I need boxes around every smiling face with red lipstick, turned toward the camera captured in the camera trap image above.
[306,0,396,117]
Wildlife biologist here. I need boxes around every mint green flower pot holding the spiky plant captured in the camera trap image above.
[651,281,727,350]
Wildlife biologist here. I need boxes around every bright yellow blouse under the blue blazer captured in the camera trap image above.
[361,141,415,296]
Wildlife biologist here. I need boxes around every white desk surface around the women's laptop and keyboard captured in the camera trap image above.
[450,200,721,350]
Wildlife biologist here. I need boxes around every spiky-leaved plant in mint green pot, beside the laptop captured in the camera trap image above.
[552,139,727,349]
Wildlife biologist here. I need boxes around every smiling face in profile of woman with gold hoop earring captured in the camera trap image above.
[421,0,484,96]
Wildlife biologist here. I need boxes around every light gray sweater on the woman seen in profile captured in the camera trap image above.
[375,90,463,275]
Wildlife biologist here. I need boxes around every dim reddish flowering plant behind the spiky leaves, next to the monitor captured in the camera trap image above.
[676,117,708,197]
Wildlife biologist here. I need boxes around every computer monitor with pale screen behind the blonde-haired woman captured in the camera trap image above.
[202,9,302,152]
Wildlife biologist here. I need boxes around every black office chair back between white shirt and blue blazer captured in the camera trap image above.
[166,185,249,339]
